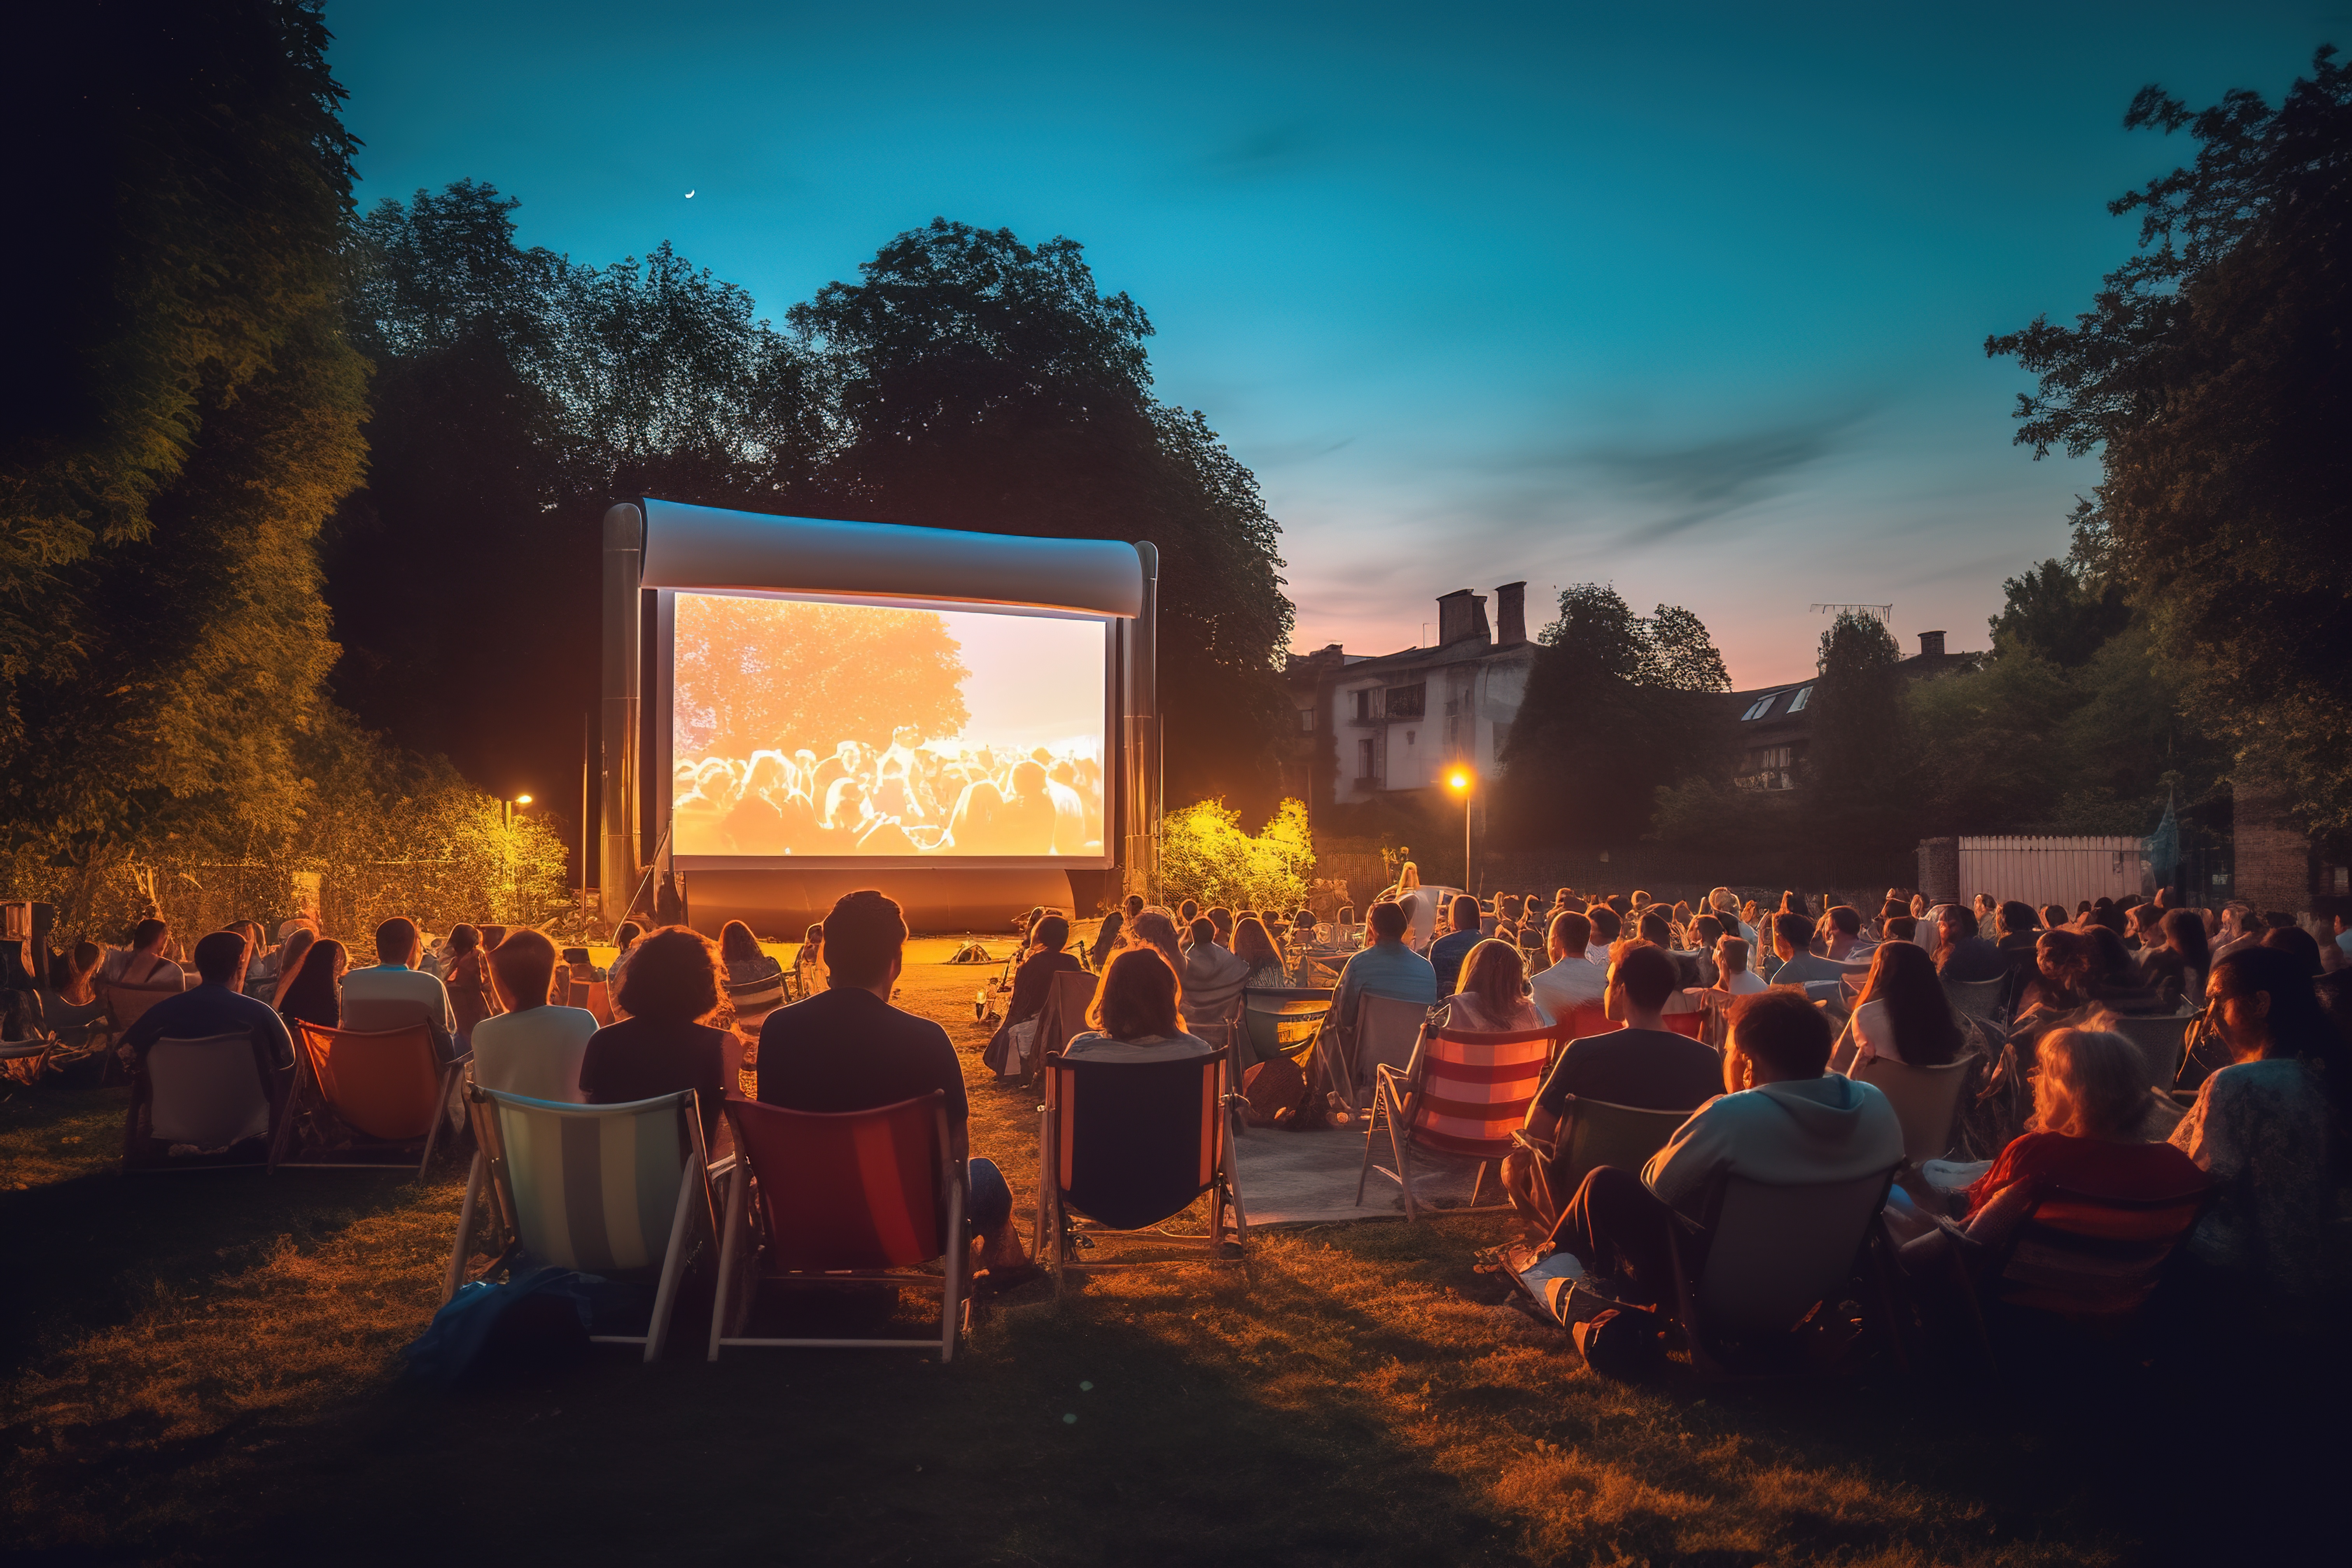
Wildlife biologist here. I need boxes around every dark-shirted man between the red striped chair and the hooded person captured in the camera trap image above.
[1503,943,1724,1215]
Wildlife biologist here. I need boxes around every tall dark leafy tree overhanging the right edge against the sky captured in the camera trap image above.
[1985,49,2352,832]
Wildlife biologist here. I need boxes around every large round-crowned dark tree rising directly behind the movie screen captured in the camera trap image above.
[790,219,1291,811]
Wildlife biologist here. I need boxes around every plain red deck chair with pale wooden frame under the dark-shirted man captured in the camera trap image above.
[710,1088,967,1361]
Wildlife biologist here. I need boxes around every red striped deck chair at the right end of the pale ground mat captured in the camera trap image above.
[1355,1027,1555,1220]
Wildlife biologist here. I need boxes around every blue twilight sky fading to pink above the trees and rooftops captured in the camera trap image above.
[329,0,2352,686]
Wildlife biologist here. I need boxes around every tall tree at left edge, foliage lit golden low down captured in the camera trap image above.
[0,0,364,926]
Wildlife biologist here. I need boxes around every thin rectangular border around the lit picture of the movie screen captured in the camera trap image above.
[642,588,1127,872]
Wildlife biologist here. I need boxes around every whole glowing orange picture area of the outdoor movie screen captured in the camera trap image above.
[670,590,1110,863]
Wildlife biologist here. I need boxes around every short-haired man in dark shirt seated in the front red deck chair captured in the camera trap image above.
[757,889,1026,1279]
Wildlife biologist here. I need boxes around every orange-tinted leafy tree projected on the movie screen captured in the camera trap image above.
[673,592,969,757]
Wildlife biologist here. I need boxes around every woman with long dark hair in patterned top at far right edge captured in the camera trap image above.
[2171,945,2352,1295]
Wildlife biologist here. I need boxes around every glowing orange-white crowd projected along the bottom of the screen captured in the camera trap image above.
[670,729,1103,856]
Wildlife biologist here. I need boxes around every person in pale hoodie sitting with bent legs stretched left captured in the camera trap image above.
[1550,992,1903,1302]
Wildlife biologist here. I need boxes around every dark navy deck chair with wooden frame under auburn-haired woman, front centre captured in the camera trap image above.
[1032,1046,1249,1295]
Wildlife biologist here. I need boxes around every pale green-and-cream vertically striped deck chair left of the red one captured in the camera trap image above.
[442,1084,732,1361]
